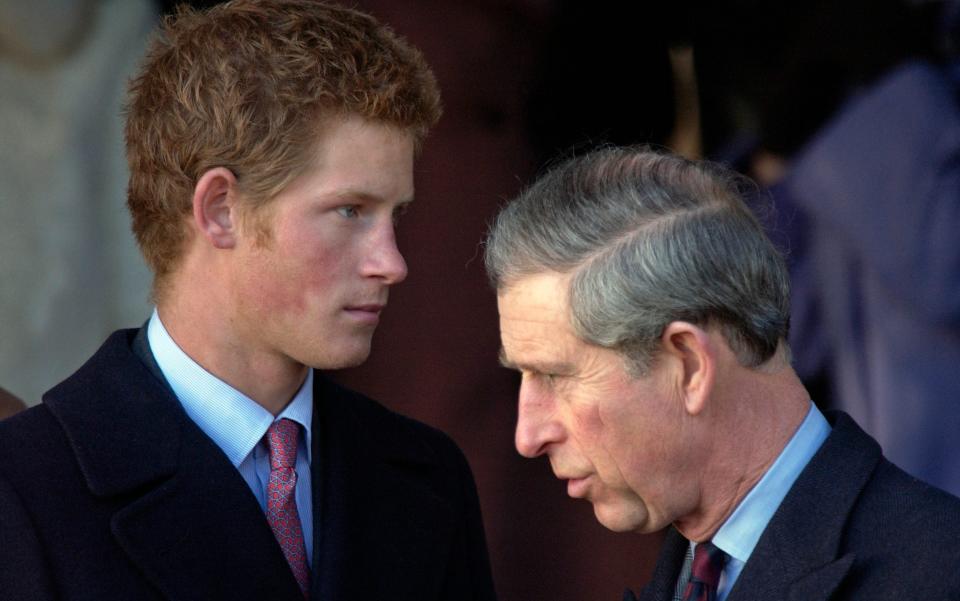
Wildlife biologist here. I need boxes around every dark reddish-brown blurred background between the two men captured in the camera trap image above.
[336,0,660,601]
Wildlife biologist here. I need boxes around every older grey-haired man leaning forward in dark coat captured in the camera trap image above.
[486,148,960,601]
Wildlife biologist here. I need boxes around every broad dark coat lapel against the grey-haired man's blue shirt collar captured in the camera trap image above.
[727,414,881,601]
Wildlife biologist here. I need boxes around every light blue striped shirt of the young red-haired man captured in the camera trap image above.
[147,309,313,565]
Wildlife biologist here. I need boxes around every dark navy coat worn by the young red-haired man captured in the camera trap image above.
[0,330,494,601]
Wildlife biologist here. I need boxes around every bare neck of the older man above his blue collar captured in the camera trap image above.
[674,358,810,542]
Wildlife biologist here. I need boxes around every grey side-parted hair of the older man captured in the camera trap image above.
[485,147,790,375]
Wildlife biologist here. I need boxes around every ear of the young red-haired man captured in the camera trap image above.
[193,167,240,248]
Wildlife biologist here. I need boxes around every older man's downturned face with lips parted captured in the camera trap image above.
[498,273,697,532]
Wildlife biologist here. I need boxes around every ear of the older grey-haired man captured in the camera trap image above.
[660,321,717,415]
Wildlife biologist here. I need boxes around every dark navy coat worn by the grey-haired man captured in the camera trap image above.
[625,407,960,601]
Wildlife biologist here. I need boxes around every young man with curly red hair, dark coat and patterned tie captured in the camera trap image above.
[0,0,494,601]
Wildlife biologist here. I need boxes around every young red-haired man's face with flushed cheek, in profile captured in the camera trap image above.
[233,117,414,369]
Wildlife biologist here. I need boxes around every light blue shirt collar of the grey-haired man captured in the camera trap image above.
[681,401,830,601]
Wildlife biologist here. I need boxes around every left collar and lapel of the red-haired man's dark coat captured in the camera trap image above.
[44,330,302,601]
